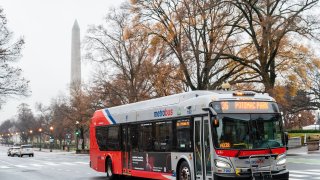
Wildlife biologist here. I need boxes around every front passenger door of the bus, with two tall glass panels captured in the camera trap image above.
[194,116,213,180]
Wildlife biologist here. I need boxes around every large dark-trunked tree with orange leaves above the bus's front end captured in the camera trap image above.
[223,0,319,93]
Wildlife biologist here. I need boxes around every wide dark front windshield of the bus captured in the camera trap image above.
[212,114,284,149]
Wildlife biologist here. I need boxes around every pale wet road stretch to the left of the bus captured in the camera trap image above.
[0,145,105,180]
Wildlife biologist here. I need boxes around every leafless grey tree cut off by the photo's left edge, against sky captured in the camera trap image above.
[0,8,29,105]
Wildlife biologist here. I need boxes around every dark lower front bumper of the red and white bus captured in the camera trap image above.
[214,170,289,180]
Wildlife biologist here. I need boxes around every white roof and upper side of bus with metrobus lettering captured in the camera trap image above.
[92,90,274,125]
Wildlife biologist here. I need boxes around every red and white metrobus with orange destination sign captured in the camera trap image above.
[90,91,289,180]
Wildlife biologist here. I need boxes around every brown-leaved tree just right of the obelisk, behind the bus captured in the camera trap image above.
[86,6,185,105]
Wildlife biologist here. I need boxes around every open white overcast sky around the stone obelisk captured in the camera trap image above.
[0,0,125,123]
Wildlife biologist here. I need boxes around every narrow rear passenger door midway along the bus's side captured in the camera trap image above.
[121,125,131,175]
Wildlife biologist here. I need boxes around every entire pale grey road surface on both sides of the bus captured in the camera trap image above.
[0,145,320,180]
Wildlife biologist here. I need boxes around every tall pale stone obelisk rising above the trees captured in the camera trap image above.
[70,20,81,89]
